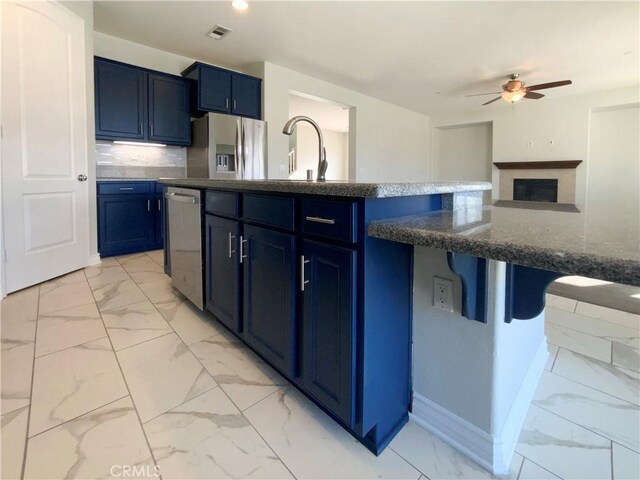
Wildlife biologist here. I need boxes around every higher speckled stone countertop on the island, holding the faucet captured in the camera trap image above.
[159,178,491,198]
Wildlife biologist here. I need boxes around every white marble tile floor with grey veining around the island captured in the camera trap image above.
[0,260,640,480]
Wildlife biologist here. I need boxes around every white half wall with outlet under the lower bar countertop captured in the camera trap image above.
[413,247,546,473]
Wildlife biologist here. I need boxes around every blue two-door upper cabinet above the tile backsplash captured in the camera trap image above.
[94,57,191,146]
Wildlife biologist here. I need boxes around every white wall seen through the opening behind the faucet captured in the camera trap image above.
[289,123,349,180]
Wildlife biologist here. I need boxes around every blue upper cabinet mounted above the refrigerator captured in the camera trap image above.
[182,62,262,119]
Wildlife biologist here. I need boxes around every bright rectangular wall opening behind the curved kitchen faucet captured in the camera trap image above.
[288,91,350,181]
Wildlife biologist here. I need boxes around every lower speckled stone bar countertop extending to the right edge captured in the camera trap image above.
[368,202,640,286]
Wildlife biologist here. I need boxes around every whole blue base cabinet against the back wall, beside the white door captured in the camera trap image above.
[97,179,164,257]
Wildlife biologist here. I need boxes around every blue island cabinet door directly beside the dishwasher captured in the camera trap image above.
[205,215,241,333]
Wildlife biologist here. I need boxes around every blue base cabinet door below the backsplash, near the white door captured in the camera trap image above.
[98,195,155,256]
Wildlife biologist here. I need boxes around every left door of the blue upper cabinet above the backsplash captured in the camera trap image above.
[94,59,147,140]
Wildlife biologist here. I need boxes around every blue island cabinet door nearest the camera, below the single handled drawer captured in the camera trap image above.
[301,240,356,427]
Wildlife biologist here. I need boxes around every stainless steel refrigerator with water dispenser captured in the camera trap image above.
[187,113,267,179]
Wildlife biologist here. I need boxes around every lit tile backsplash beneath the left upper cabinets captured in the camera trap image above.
[96,140,187,178]
